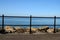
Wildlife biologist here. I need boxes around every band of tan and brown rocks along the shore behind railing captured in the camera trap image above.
[0,26,60,34]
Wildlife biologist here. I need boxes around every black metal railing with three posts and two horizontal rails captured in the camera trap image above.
[0,15,60,34]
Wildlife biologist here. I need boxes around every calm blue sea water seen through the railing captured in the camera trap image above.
[0,17,60,28]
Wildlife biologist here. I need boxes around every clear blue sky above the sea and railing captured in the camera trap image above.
[0,0,60,16]
